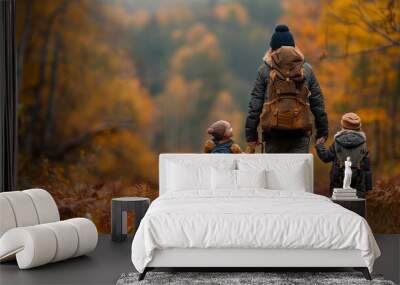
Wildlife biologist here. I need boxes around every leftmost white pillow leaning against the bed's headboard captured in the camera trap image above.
[167,162,211,191]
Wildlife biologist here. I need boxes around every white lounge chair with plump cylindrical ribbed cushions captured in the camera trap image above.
[0,189,98,269]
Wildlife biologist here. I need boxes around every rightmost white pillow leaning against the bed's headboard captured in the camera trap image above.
[267,163,307,192]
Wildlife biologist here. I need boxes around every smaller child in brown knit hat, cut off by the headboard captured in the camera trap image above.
[204,120,242,153]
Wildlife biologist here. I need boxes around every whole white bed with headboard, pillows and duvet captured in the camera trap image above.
[132,154,380,279]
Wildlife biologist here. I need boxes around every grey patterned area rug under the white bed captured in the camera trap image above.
[117,272,395,285]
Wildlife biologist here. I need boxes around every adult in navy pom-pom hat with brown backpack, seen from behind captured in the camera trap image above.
[246,25,328,153]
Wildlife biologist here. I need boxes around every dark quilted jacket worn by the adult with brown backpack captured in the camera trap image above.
[246,59,328,142]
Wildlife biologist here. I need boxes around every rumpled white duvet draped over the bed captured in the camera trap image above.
[132,189,380,272]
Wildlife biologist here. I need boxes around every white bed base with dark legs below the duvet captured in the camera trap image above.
[139,248,371,280]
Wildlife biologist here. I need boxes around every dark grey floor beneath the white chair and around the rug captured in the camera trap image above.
[0,235,400,285]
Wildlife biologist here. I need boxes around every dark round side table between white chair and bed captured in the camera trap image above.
[111,197,150,241]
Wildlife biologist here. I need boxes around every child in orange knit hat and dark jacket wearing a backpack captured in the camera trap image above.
[315,113,372,197]
